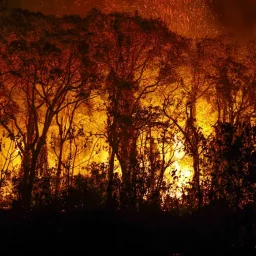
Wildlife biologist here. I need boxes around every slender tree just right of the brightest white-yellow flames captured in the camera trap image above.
[162,39,218,207]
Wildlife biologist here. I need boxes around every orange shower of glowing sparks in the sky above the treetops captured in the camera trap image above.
[98,0,220,38]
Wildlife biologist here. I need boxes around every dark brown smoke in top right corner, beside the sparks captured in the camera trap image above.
[208,0,256,40]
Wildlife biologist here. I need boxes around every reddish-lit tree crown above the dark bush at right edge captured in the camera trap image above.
[215,51,255,124]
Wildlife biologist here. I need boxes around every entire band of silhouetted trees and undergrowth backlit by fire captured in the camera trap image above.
[0,9,256,255]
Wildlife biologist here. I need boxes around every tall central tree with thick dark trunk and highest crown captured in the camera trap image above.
[88,10,181,207]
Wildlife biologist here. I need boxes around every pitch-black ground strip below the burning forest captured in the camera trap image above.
[0,209,256,256]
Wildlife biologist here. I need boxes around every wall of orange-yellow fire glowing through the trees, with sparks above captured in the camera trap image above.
[0,6,255,211]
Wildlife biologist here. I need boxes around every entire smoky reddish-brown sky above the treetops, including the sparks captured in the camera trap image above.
[15,0,256,40]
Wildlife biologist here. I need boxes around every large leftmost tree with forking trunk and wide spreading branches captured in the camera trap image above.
[1,35,90,208]
